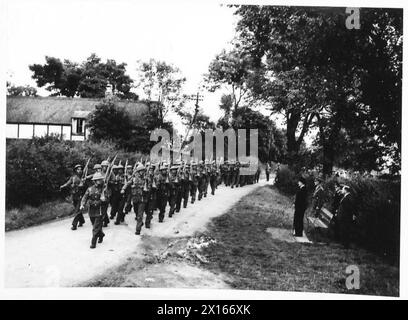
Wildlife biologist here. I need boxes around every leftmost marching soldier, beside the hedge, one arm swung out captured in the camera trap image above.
[60,164,85,230]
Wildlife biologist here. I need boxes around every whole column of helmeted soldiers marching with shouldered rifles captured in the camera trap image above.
[60,157,260,248]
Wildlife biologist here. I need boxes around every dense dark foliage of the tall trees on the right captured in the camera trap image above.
[235,6,402,173]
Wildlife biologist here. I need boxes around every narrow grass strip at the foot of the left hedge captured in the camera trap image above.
[5,200,73,231]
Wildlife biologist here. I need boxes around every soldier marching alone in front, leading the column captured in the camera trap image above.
[80,172,105,249]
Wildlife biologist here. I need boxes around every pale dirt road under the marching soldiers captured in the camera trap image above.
[5,180,267,287]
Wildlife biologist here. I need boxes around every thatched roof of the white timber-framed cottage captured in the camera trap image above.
[7,96,153,124]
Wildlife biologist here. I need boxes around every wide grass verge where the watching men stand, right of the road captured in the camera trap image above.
[199,187,399,296]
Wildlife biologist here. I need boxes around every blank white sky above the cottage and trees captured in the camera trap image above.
[6,0,242,121]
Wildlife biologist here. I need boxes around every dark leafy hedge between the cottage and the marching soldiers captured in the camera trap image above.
[6,136,145,208]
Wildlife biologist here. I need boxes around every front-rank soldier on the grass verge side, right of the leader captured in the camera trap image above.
[121,163,147,235]
